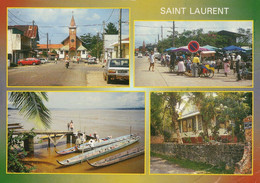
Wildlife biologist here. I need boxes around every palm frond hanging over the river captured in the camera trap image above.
[9,92,51,129]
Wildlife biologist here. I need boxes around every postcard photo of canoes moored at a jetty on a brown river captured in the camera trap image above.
[6,92,145,174]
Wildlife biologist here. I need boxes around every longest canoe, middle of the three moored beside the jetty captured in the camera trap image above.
[57,136,140,166]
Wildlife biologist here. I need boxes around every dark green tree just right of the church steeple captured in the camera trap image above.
[80,33,103,58]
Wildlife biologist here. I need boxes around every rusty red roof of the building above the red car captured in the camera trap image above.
[8,25,39,41]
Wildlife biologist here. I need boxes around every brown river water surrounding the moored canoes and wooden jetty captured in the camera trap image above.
[8,109,145,173]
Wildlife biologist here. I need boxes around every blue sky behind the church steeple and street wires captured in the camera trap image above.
[8,8,129,44]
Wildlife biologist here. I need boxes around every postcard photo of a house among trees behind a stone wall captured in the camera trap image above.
[150,91,254,175]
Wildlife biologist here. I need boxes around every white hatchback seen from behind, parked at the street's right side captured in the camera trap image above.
[103,58,129,84]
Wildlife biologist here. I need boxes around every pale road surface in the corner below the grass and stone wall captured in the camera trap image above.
[150,156,196,174]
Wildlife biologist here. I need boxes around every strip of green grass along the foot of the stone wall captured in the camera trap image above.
[151,152,234,174]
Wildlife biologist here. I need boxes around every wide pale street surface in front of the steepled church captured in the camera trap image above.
[8,61,128,87]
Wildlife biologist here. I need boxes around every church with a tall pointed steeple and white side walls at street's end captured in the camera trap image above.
[59,15,88,59]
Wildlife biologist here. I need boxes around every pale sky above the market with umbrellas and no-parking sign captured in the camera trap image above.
[135,21,253,47]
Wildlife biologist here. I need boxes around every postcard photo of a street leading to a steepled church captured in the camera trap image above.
[7,8,129,87]
